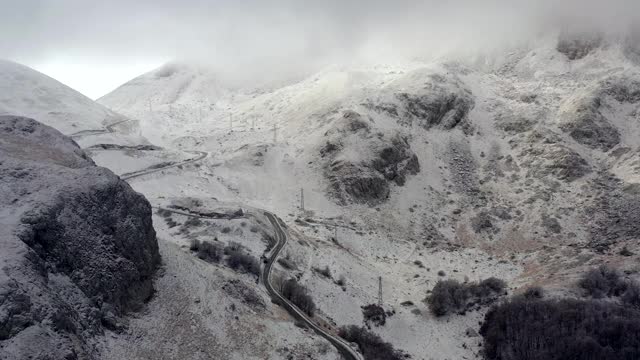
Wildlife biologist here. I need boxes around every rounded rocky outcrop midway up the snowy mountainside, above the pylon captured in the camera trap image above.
[319,111,420,205]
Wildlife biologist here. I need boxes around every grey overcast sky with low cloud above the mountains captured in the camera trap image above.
[0,0,640,98]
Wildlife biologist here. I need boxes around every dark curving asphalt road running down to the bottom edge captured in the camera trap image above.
[262,211,364,360]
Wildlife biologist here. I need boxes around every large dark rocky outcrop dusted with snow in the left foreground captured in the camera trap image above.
[0,116,160,359]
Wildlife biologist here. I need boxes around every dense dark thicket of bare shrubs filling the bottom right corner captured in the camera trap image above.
[480,296,640,360]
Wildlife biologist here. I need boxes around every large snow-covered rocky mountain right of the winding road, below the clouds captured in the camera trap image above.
[94,36,640,359]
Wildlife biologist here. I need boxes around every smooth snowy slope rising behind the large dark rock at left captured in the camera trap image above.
[0,60,125,135]
